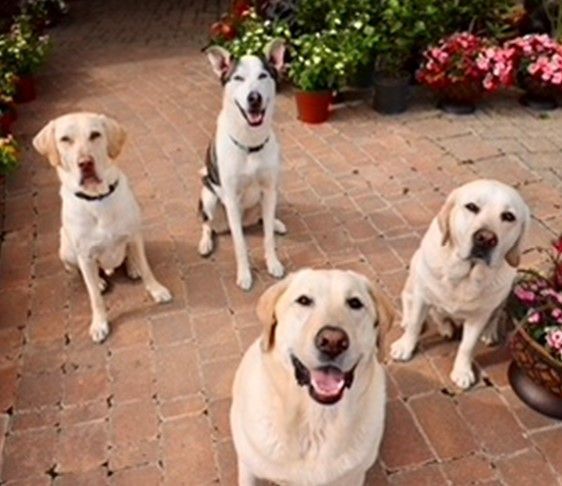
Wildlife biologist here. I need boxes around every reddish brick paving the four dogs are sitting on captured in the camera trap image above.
[0,0,562,486]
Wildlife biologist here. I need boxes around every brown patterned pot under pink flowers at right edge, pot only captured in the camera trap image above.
[509,327,562,419]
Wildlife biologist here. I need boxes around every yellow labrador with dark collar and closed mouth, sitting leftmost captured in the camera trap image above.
[33,113,172,342]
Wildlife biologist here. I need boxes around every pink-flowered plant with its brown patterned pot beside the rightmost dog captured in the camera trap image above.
[507,234,562,418]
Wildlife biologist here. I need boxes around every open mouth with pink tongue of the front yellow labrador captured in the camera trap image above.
[291,354,359,405]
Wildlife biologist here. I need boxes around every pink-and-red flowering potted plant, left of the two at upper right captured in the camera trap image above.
[416,32,513,114]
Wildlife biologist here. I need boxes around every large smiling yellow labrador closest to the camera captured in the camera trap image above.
[230,269,390,486]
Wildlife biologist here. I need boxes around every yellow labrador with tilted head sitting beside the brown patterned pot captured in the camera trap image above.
[391,180,530,388]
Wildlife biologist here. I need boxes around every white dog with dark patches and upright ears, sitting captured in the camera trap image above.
[198,40,286,290]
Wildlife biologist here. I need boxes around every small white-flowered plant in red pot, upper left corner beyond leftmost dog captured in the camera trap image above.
[0,15,49,103]
